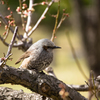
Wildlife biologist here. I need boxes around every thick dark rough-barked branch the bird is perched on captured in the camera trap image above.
[0,65,87,100]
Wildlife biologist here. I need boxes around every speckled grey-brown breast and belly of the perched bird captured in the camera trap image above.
[29,52,53,71]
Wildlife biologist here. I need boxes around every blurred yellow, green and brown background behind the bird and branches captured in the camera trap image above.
[0,0,100,97]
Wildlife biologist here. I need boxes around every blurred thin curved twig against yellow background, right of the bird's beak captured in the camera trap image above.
[67,33,88,80]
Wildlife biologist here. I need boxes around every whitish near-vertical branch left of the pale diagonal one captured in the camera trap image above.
[23,0,33,38]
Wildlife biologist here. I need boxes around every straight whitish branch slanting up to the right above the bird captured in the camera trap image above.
[28,0,54,37]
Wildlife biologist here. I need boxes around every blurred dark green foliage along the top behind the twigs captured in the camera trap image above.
[0,0,92,29]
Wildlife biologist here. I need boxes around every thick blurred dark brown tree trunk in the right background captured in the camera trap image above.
[73,0,100,76]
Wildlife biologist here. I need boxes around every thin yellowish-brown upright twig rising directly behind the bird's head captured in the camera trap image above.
[51,0,60,41]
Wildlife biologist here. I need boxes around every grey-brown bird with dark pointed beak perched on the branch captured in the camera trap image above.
[15,39,61,72]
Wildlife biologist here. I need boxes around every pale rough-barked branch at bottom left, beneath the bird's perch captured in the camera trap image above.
[0,87,52,100]
